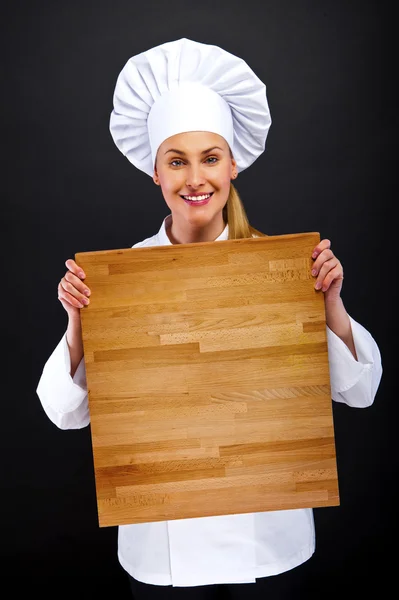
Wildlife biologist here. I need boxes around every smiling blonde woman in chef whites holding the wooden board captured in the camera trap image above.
[37,39,382,598]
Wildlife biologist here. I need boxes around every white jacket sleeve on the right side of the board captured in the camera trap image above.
[327,317,382,408]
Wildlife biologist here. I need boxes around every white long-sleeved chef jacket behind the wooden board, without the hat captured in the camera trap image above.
[37,215,382,586]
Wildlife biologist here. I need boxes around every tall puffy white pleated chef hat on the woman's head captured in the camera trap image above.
[110,38,271,177]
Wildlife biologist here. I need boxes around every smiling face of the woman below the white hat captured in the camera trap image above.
[154,131,237,228]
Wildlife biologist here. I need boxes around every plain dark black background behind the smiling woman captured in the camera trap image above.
[0,0,398,598]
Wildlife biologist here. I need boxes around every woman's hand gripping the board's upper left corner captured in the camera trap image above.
[58,258,91,319]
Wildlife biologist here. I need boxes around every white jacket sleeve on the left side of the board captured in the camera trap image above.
[36,333,90,429]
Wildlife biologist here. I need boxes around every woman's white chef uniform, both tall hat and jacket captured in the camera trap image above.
[37,38,382,587]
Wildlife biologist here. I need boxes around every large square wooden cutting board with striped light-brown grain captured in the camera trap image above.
[75,233,339,527]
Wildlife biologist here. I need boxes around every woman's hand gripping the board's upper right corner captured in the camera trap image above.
[312,240,344,301]
